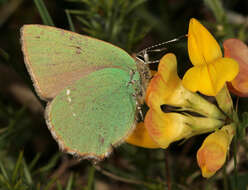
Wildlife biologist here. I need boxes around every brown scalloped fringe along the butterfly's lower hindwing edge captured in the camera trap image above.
[45,102,138,163]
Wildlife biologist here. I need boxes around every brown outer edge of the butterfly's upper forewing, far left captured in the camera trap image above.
[20,25,51,101]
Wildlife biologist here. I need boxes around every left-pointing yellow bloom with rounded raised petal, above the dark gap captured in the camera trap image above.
[146,53,224,119]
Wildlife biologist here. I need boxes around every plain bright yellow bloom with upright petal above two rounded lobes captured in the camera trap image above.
[183,18,239,96]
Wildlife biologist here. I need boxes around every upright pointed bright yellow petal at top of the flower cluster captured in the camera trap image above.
[188,18,222,65]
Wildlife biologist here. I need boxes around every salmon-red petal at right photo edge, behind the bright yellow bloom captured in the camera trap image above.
[223,39,248,97]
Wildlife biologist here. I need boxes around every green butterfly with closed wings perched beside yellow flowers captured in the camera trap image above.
[21,25,149,160]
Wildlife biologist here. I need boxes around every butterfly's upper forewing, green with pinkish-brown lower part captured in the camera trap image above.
[21,25,136,100]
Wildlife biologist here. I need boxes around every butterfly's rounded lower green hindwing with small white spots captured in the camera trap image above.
[46,68,136,159]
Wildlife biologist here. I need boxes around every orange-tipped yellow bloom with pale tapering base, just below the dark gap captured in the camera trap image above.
[144,109,224,148]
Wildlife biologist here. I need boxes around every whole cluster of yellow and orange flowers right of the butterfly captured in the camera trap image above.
[126,19,244,178]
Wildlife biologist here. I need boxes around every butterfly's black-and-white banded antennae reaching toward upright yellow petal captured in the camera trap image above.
[136,34,188,64]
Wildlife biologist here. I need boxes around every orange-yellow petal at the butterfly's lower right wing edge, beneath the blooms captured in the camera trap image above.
[126,122,160,148]
